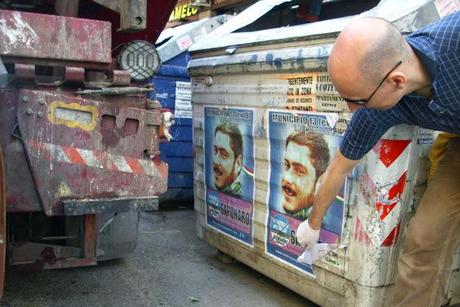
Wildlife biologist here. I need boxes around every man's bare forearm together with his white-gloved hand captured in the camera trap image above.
[297,149,359,248]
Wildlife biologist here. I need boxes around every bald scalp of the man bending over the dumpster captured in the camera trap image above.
[328,17,406,98]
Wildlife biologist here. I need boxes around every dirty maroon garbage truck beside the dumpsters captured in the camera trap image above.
[0,0,176,298]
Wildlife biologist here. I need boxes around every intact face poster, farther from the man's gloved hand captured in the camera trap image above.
[204,107,254,246]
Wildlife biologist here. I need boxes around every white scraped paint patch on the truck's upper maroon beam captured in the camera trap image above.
[0,12,39,53]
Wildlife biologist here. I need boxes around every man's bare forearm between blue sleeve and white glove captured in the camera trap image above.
[308,150,359,229]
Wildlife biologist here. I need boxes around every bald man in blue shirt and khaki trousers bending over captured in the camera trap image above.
[297,12,460,307]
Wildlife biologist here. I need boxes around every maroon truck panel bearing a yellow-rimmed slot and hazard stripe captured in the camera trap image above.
[17,90,168,215]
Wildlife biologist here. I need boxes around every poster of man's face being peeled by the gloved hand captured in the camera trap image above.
[266,111,344,274]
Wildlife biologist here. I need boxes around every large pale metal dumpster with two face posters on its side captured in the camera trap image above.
[189,0,458,306]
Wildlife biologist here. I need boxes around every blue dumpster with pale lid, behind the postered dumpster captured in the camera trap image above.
[149,16,227,203]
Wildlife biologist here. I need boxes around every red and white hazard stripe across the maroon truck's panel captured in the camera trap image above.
[26,140,160,176]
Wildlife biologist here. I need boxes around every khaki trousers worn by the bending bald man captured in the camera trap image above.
[393,138,460,307]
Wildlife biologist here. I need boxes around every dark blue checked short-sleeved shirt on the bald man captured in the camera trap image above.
[340,12,460,160]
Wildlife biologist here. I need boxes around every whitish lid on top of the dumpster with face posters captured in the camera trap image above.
[189,0,434,52]
